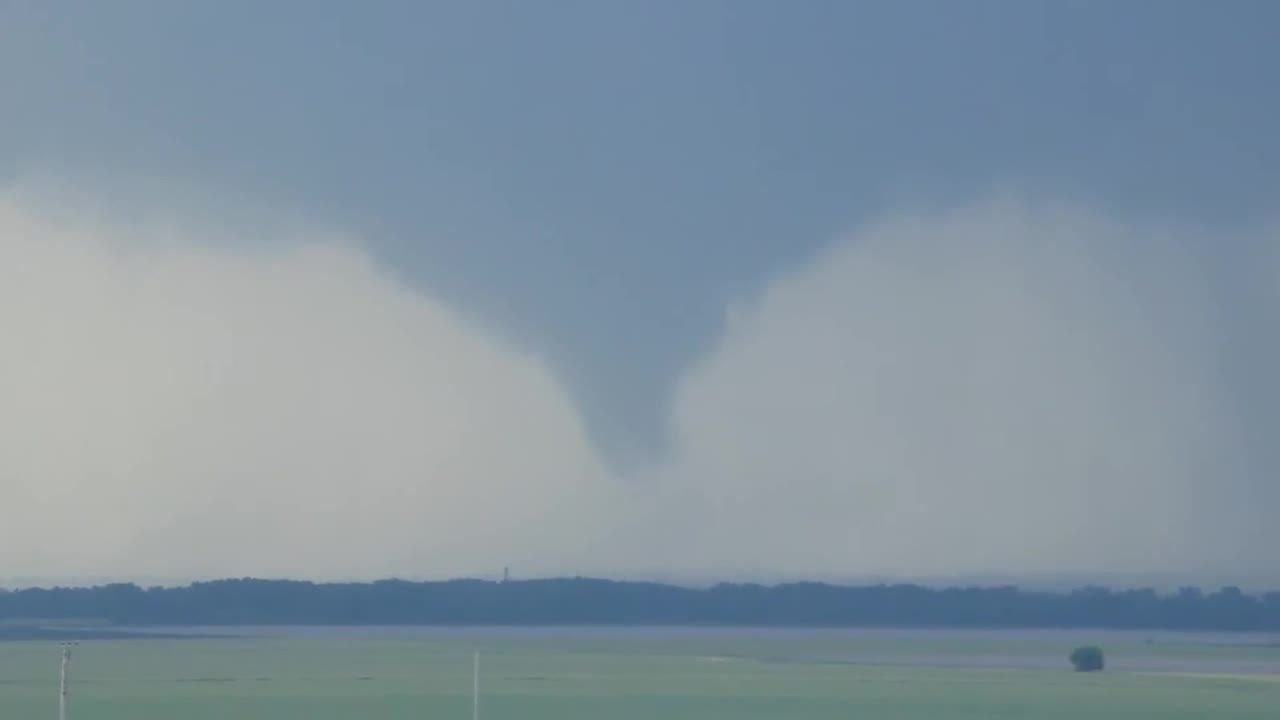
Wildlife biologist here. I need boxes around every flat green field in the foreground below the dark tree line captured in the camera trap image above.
[0,630,1280,720]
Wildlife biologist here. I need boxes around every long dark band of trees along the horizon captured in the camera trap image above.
[0,578,1280,630]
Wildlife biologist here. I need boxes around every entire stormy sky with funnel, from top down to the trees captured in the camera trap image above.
[0,0,1280,587]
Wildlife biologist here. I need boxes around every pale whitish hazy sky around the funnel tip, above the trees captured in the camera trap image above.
[0,190,1280,580]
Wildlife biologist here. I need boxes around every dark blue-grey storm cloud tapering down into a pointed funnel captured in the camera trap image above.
[0,0,1280,466]
